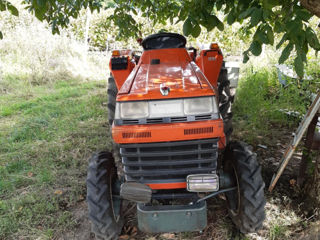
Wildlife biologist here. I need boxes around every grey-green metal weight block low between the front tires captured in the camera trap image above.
[137,201,207,233]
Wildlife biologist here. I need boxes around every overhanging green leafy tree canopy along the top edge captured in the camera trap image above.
[0,0,320,77]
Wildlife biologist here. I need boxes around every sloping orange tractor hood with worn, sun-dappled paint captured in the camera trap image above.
[117,49,214,101]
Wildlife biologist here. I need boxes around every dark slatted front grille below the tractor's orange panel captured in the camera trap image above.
[120,139,218,183]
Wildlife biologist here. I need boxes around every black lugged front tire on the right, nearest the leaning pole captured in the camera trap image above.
[224,142,266,233]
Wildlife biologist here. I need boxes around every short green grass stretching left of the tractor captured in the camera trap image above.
[0,76,110,239]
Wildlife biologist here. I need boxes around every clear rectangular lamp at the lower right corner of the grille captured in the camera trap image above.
[187,173,219,192]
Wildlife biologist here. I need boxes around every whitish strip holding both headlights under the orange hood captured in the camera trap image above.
[115,96,218,119]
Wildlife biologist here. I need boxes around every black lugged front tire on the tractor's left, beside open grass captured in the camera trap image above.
[87,152,123,240]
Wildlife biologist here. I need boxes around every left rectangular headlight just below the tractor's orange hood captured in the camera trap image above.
[120,101,149,119]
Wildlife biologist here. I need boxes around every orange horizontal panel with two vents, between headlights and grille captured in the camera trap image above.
[112,119,224,144]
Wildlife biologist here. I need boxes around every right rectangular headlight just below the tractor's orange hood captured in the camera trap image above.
[184,97,218,115]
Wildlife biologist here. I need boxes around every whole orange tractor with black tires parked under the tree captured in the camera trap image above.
[87,33,265,239]
